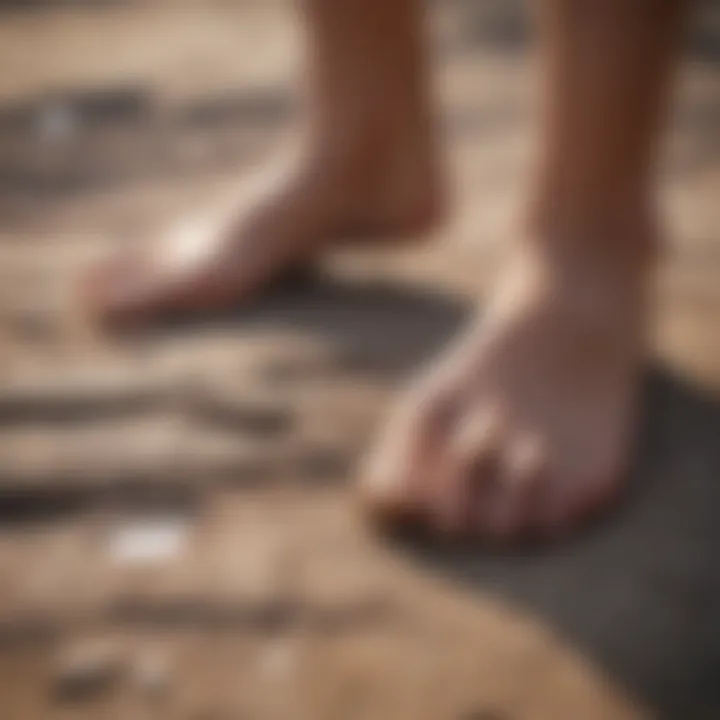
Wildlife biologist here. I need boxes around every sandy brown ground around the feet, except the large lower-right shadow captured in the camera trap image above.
[0,0,720,720]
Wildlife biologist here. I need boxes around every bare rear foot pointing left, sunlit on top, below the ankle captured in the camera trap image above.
[82,132,441,325]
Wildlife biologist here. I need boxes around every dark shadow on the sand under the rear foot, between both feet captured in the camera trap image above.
[136,267,472,381]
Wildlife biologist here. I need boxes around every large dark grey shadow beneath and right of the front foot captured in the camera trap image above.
[390,371,720,720]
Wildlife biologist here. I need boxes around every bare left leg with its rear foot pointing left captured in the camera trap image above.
[84,0,442,323]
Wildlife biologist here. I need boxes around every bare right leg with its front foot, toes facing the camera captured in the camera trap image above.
[364,0,682,540]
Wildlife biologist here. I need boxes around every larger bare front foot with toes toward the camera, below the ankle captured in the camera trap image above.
[362,236,647,541]
